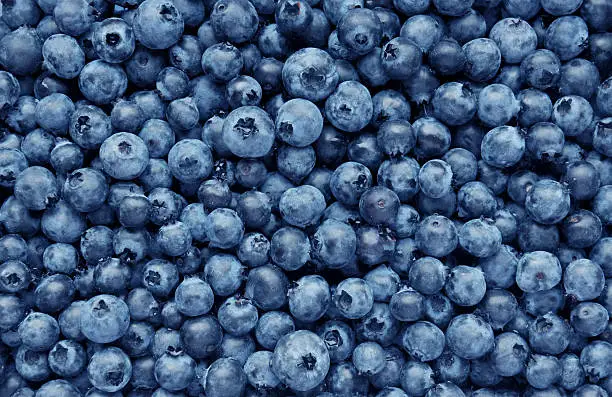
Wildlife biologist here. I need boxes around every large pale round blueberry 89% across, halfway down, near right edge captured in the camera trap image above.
[525,179,570,225]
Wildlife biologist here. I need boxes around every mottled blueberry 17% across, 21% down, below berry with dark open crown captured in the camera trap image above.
[79,59,127,105]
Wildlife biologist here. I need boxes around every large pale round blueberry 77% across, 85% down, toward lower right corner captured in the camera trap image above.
[446,314,494,360]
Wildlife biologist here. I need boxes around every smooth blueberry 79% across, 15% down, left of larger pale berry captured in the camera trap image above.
[463,38,501,82]
